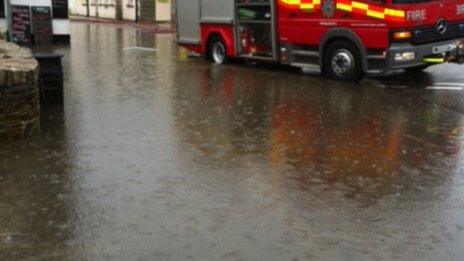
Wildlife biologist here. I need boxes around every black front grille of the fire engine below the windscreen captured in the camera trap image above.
[412,23,464,44]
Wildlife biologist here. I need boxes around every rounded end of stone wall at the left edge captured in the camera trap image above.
[0,42,40,144]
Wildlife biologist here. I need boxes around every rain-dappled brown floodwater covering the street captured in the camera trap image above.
[0,23,464,260]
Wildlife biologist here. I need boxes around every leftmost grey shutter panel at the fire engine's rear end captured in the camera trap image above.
[176,0,201,45]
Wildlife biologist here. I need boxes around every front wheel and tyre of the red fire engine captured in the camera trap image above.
[324,40,365,82]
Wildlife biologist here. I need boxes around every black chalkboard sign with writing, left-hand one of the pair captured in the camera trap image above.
[11,5,32,44]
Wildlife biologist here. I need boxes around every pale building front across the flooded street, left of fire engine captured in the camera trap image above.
[69,0,172,23]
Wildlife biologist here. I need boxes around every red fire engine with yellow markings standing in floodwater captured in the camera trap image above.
[176,0,464,82]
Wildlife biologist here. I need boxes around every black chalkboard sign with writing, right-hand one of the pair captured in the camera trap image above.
[31,6,53,44]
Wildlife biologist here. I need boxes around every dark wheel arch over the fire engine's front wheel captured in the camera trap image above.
[319,28,368,72]
